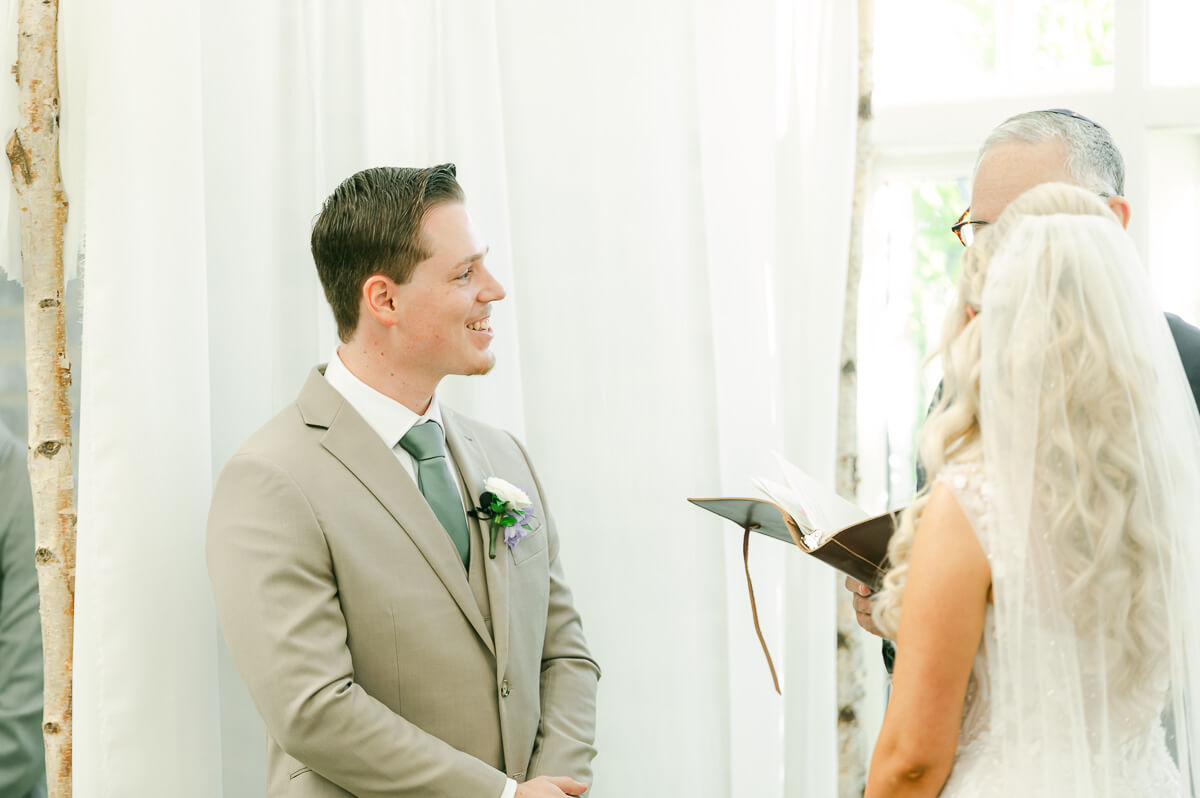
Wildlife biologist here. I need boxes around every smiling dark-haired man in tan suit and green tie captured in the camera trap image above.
[208,164,600,798]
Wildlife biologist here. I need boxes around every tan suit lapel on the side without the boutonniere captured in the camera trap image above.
[298,370,496,655]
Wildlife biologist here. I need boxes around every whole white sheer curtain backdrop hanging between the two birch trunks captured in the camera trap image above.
[2,0,856,798]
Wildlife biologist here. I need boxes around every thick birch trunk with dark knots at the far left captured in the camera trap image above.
[6,0,76,798]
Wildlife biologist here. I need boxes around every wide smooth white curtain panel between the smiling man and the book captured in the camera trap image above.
[497,0,732,798]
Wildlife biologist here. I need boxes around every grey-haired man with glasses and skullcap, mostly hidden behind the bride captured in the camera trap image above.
[846,108,1200,643]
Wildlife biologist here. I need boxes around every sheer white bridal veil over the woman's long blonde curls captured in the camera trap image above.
[965,184,1200,796]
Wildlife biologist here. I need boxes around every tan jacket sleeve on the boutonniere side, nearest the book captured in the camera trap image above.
[514,438,600,786]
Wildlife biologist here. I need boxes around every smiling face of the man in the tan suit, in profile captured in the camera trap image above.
[395,203,504,380]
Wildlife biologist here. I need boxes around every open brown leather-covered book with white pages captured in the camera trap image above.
[688,455,895,588]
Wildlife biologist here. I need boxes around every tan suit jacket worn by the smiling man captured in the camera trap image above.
[208,368,600,798]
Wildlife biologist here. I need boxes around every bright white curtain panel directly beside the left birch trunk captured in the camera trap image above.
[71,1,221,798]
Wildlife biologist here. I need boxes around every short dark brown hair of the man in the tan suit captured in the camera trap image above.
[311,163,463,341]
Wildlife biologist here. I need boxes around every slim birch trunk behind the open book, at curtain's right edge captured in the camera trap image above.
[836,0,874,798]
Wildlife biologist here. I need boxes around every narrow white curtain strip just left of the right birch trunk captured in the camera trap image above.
[775,0,874,798]
